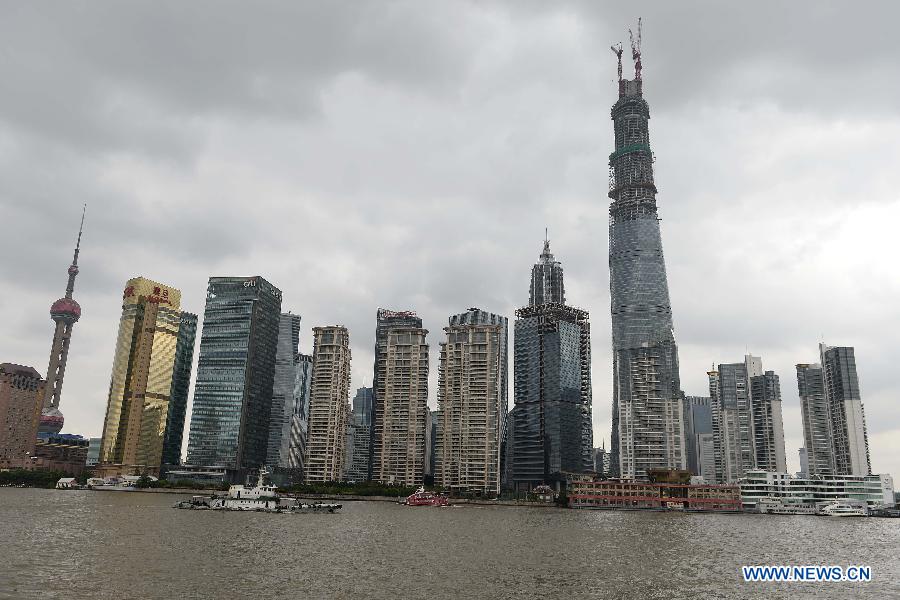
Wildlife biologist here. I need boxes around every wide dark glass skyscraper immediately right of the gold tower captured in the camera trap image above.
[187,276,281,481]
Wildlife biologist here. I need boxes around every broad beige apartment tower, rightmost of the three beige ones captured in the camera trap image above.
[434,310,510,497]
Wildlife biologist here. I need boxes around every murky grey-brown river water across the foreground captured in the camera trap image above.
[0,488,900,600]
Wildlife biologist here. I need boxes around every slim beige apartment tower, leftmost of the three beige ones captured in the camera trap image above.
[303,325,350,482]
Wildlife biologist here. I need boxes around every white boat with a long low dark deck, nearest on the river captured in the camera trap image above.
[175,469,343,513]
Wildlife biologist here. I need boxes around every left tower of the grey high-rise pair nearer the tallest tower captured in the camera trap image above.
[707,354,762,483]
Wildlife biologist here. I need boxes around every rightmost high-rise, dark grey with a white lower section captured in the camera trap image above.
[819,344,872,475]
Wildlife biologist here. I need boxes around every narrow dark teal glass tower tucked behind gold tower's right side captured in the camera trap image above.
[163,312,197,465]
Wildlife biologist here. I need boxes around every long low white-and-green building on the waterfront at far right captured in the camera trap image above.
[739,470,894,510]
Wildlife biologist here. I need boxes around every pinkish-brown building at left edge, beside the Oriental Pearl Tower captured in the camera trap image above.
[0,363,45,469]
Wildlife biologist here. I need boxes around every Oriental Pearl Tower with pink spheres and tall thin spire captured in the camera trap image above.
[38,207,87,435]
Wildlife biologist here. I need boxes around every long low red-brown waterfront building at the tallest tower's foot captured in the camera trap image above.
[569,479,741,512]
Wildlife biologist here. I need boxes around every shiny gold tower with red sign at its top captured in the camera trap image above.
[97,277,181,477]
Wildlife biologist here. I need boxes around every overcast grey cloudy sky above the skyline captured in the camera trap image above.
[0,0,900,475]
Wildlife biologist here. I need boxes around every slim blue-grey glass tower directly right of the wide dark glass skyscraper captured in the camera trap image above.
[266,312,300,469]
